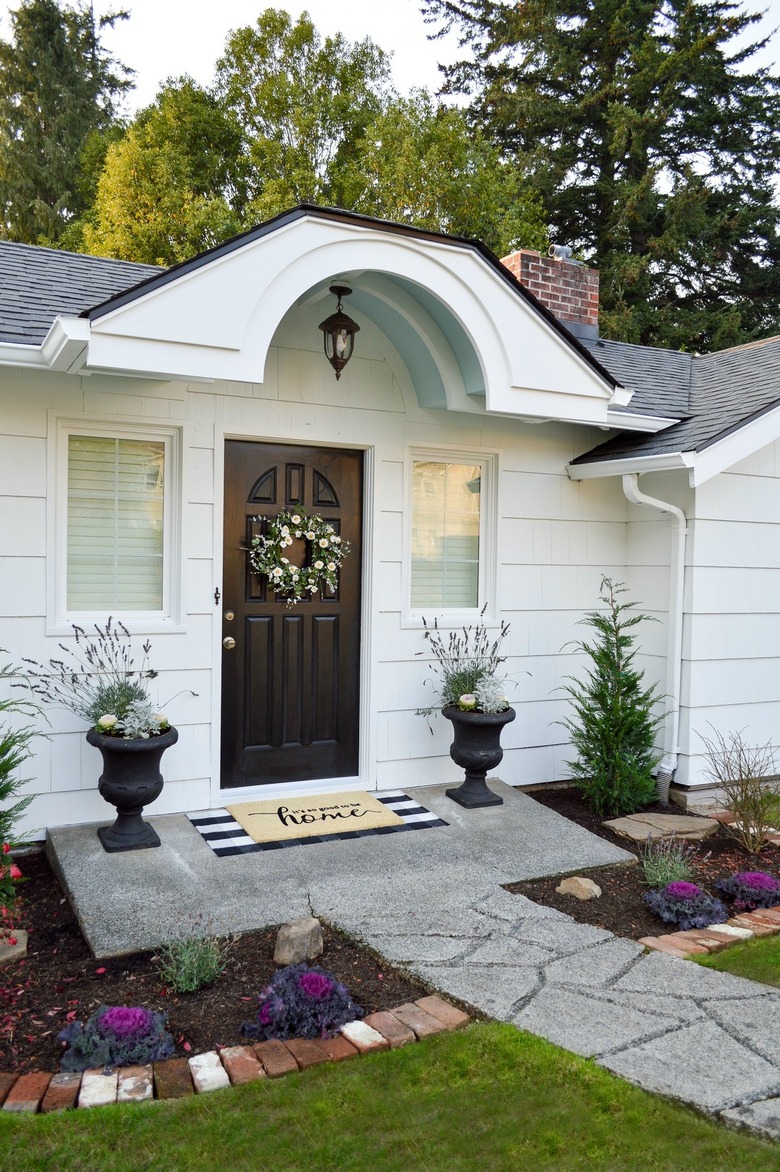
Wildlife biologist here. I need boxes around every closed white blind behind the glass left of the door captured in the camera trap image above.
[67,435,165,611]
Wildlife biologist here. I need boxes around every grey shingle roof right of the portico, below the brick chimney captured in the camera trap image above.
[573,336,780,464]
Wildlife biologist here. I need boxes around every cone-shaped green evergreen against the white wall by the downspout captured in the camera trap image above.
[560,578,661,818]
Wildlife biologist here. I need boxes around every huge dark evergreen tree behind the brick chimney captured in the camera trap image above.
[423,0,780,349]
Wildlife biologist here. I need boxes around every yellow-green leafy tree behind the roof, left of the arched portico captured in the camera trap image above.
[81,77,244,265]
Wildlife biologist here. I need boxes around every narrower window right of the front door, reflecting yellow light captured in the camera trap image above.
[410,455,486,611]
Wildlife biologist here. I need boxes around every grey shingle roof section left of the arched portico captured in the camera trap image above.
[0,240,160,346]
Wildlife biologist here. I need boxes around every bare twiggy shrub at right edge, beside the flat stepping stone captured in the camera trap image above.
[699,725,780,854]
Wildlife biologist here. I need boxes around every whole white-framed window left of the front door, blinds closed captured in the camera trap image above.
[57,424,178,618]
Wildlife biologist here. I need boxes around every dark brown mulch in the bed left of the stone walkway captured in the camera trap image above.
[0,854,429,1072]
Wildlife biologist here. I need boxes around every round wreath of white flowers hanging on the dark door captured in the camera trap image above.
[249,509,349,606]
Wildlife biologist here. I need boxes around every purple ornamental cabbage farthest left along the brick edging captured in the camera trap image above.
[59,1006,173,1071]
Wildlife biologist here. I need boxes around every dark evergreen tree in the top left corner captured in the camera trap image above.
[0,0,131,244]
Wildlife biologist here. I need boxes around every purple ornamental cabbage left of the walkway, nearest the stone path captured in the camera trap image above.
[241,963,363,1041]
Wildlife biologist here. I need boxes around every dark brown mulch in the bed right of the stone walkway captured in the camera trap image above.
[507,789,780,940]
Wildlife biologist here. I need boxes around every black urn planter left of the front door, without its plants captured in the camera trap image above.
[87,728,179,852]
